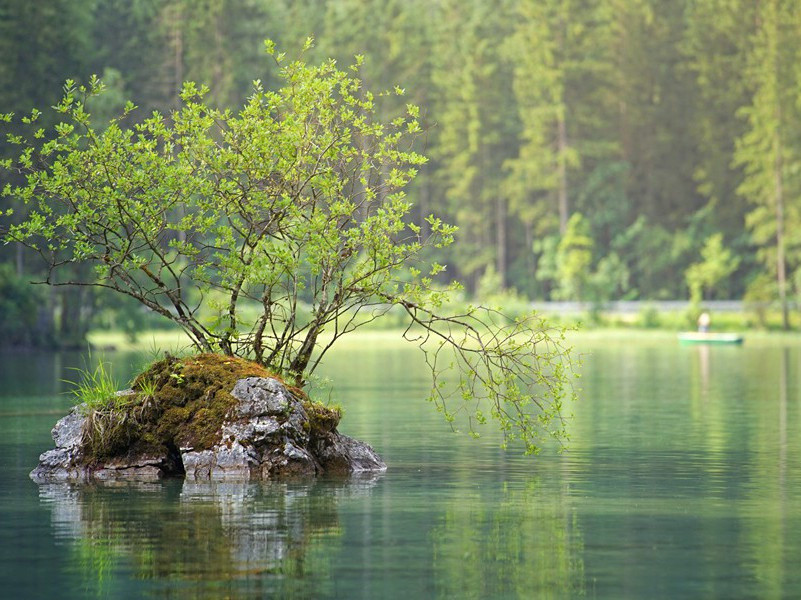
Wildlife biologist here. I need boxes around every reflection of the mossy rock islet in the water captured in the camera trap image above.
[39,474,381,598]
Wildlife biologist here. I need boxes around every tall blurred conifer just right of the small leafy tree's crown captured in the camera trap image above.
[431,0,519,290]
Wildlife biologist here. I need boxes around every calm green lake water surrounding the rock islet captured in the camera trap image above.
[0,338,801,599]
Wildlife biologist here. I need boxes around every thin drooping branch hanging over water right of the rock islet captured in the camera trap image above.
[399,300,575,454]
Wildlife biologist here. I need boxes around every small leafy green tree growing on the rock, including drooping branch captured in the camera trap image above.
[3,42,569,452]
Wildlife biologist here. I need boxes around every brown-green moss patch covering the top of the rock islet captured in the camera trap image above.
[84,354,280,462]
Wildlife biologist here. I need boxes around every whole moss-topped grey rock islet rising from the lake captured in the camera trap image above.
[31,354,386,481]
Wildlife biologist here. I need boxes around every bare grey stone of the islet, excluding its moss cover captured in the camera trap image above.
[31,377,386,482]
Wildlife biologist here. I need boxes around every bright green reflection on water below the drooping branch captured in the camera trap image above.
[432,477,584,598]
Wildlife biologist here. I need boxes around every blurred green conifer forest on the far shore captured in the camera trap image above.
[0,0,801,345]
